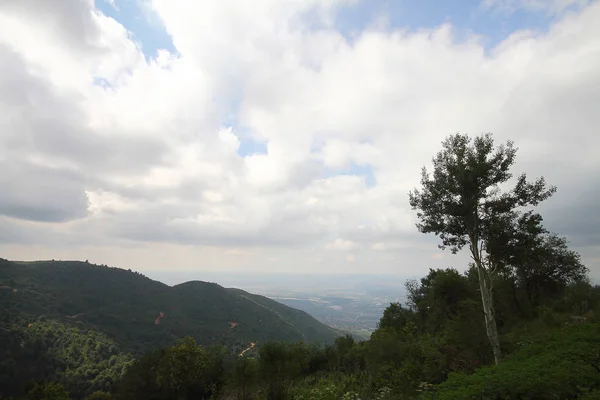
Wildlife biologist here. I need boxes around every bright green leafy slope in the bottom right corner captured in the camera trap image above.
[424,323,600,400]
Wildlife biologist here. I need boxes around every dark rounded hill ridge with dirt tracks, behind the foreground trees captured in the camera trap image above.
[0,259,341,353]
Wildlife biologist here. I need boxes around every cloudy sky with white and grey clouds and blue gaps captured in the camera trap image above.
[0,0,600,276]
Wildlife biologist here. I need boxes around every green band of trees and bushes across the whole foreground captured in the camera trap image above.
[7,269,600,400]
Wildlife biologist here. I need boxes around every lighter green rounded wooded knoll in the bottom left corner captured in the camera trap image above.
[0,321,133,397]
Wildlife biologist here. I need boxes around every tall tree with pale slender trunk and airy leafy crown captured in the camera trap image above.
[409,133,556,364]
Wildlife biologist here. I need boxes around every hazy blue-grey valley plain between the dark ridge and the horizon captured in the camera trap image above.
[146,271,412,339]
